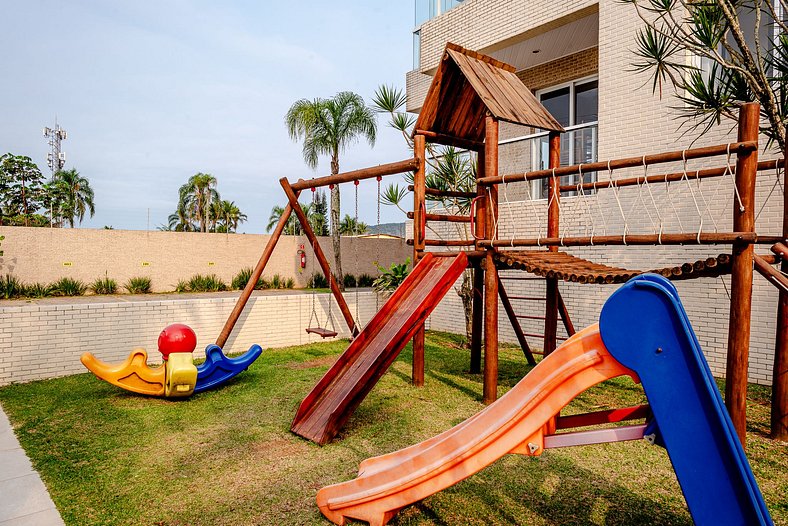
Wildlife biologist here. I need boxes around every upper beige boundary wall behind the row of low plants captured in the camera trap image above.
[0,227,411,292]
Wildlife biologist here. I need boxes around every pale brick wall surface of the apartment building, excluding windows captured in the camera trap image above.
[406,0,783,384]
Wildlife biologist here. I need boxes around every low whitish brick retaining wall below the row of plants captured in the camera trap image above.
[0,291,377,385]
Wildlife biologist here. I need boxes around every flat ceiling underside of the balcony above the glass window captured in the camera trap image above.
[483,12,599,71]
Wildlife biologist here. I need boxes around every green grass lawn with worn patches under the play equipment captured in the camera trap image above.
[0,333,788,525]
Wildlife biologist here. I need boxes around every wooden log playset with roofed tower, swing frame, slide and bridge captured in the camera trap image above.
[216,44,788,443]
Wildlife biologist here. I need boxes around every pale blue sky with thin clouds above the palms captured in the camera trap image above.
[0,0,413,233]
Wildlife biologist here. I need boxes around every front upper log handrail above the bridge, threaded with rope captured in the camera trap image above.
[476,140,758,186]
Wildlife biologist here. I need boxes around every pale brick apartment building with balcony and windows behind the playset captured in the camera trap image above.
[406,0,783,384]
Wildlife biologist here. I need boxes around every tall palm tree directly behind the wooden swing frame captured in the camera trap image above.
[285,91,377,286]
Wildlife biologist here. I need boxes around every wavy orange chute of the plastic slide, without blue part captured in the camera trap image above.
[317,325,637,526]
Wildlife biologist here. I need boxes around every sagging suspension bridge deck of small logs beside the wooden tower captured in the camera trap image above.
[495,250,731,284]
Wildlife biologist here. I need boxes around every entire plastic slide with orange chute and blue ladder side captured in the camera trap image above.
[317,274,773,526]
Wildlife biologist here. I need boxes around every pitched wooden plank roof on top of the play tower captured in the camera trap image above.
[415,43,564,141]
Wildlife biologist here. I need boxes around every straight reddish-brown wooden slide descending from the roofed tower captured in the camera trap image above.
[290,252,468,445]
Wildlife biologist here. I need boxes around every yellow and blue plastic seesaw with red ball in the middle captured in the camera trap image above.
[80,323,263,398]
